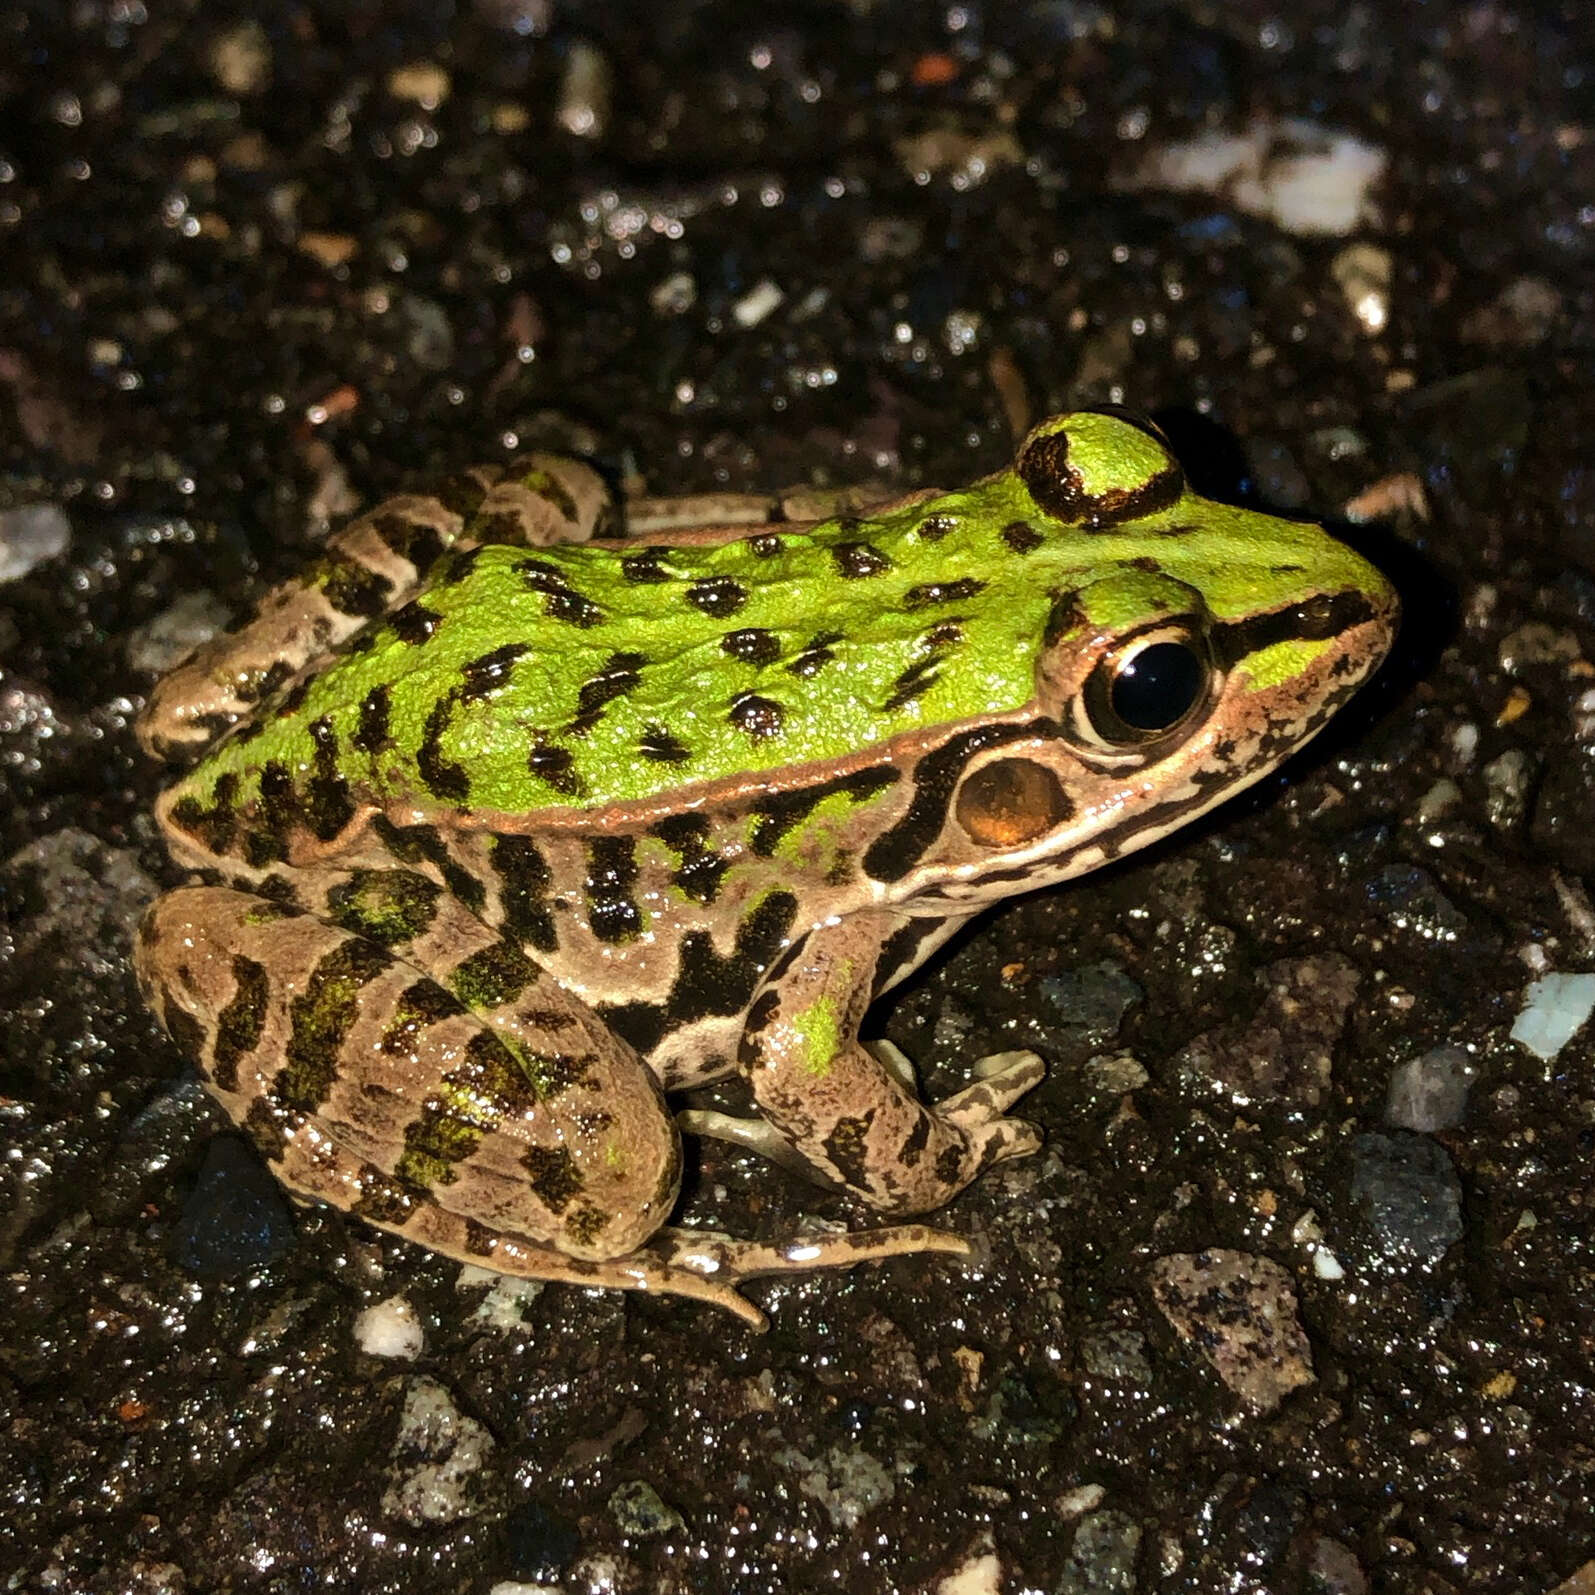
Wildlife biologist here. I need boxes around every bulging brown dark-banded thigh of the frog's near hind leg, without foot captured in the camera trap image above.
[136,887,681,1278]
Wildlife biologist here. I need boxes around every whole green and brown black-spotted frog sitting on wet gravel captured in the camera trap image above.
[134,410,1397,1329]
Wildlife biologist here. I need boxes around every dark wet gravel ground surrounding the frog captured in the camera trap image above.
[0,0,1595,1595]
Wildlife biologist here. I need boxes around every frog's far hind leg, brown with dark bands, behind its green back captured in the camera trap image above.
[137,455,609,759]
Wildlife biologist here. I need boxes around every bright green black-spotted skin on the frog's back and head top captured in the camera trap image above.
[165,405,1384,815]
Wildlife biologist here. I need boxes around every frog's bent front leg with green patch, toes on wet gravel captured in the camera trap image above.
[727,914,1045,1214]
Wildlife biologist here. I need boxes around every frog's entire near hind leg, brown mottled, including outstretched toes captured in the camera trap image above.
[136,893,968,1329]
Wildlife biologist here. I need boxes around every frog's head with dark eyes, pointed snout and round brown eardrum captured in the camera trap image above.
[898,413,1397,904]
